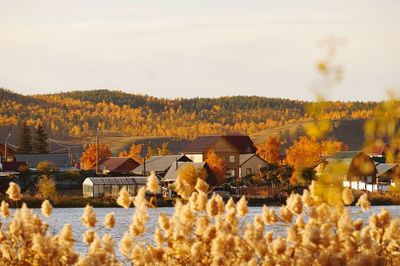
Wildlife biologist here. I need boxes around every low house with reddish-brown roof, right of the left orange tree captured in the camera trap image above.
[92,157,140,175]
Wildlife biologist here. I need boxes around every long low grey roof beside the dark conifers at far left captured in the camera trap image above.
[15,153,72,168]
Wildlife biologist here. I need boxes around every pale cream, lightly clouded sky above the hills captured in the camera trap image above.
[0,0,400,101]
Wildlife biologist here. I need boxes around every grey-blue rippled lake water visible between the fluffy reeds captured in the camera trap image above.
[9,206,400,253]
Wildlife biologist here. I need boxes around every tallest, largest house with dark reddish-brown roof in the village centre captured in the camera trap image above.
[182,135,256,177]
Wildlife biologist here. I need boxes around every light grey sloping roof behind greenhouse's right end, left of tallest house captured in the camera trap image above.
[134,154,190,173]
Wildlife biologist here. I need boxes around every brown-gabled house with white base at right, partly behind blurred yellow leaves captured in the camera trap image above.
[317,151,378,191]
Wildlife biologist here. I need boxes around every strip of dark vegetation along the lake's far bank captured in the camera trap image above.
[2,190,400,208]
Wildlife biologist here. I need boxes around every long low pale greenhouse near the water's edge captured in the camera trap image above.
[82,176,151,197]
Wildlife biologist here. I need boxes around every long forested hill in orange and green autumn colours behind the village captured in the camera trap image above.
[0,89,377,139]
